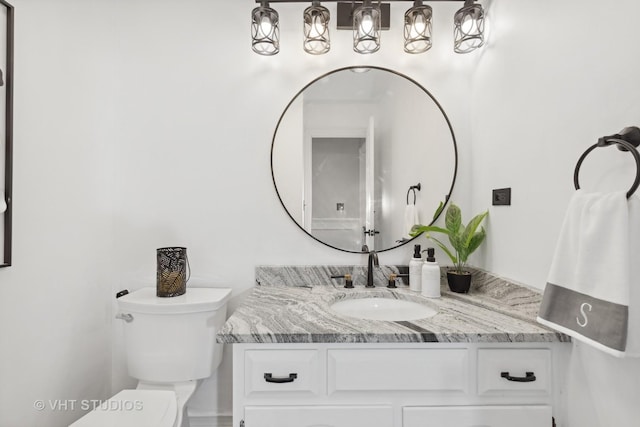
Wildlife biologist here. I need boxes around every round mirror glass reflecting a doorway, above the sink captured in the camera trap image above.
[271,67,458,252]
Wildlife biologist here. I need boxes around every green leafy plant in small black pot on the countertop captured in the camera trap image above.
[411,202,489,293]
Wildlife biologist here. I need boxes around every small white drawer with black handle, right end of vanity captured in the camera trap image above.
[478,349,551,396]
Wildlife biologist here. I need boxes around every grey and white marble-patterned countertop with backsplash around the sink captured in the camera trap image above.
[217,266,570,343]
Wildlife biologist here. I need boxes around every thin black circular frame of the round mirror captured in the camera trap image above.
[270,65,458,254]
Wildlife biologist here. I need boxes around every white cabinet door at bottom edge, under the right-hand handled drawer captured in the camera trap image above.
[402,405,552,427]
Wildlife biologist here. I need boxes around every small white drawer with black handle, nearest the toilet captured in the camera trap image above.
[244,350,320,396]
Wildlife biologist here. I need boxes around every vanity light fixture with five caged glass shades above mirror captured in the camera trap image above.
[251,0,485,55]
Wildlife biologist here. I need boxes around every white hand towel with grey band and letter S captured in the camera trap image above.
[538,190,640,357]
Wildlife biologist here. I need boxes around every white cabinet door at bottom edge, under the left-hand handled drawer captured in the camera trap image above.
[244,406,393,427]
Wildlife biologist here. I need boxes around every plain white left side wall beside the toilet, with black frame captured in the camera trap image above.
[0,0,118,427]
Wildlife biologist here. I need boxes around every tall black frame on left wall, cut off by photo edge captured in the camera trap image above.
[0,0,14,268]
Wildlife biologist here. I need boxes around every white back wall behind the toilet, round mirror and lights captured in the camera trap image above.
[112,0,476,422]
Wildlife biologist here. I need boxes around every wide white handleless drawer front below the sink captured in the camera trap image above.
[328,349,469,394]
